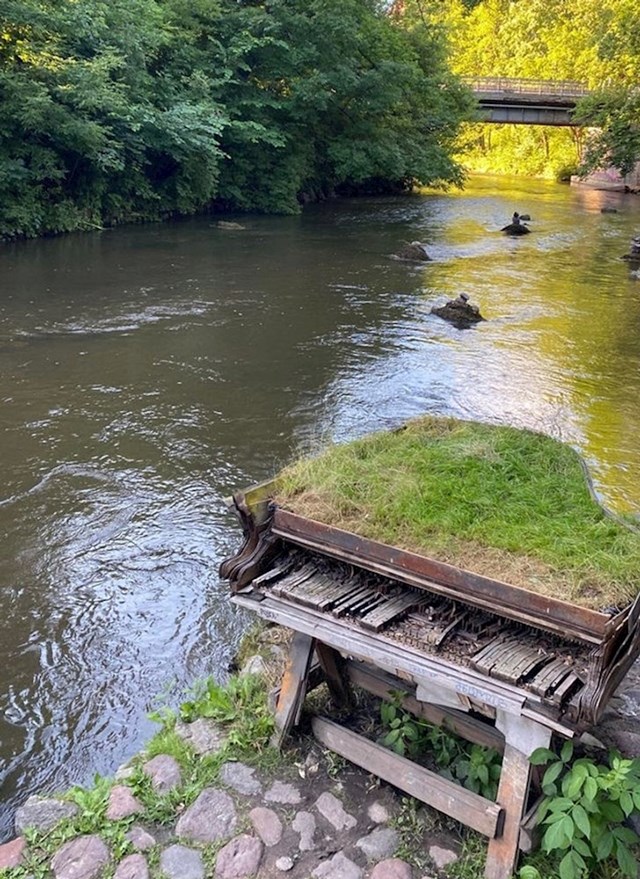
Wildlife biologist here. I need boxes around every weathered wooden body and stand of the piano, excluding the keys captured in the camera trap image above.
[220,484,640,879]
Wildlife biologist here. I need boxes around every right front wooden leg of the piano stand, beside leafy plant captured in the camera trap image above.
[484,711,551,879]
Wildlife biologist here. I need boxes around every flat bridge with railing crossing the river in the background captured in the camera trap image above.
[464,76,589,125]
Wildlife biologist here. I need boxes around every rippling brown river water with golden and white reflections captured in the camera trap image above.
[0,177,640,840]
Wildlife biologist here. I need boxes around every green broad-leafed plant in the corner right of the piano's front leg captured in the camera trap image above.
[522,742,640,879]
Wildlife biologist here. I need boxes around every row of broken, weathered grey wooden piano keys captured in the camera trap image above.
[252,546,592,706]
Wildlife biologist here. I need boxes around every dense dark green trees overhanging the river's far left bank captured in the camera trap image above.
[0,0,470,237]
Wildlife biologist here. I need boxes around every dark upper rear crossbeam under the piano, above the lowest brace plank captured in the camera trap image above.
[346,660,504,753]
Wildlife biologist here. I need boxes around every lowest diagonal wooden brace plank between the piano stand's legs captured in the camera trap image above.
[311,717,502,839]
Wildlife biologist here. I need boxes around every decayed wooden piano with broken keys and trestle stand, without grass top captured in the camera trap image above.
[220,484,640,879]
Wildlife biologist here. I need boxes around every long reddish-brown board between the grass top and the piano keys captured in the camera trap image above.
[272,508,610,644]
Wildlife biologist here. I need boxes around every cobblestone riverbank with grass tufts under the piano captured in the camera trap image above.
[0,626,640,879]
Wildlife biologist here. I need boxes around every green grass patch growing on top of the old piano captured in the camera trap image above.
[276,417,640,610]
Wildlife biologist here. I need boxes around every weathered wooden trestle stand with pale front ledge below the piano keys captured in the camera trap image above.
[232,595,560,879]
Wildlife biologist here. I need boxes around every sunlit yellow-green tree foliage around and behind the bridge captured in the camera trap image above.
[429,0,640,176]
